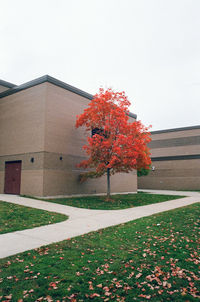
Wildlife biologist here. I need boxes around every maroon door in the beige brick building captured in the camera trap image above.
[4,161,22,195]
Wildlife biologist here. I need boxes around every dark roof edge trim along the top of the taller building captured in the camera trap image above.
[0,75,137,119]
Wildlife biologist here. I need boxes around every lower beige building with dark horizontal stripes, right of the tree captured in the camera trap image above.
[138,125,200,190]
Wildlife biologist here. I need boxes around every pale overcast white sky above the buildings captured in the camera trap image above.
[0,0,200,130]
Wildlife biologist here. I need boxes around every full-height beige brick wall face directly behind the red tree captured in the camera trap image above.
[44,83,137,196]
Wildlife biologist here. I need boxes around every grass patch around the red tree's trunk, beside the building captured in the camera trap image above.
[38,192,184,210]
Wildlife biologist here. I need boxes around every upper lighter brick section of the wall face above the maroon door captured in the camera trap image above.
[0,83,46,156]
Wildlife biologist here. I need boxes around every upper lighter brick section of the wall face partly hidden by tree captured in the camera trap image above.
[45,83,90,156]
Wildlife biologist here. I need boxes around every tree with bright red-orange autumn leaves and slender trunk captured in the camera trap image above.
[76,88,151,199]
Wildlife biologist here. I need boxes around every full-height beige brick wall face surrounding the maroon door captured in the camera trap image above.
[0,83,46,195]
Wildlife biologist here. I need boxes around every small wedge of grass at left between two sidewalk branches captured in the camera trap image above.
[0,201,68,234]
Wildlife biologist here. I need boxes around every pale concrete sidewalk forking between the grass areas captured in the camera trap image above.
[0,190,200,258]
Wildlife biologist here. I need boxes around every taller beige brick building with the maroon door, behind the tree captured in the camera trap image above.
[0,75,137,196]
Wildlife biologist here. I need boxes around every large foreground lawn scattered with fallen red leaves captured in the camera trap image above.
[0,203,200,302]
